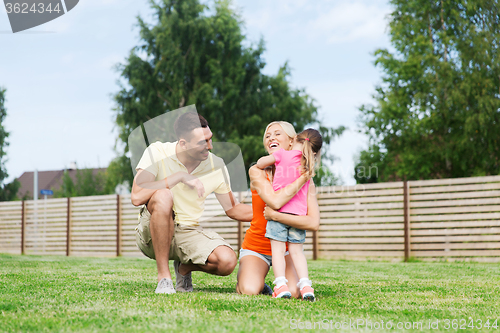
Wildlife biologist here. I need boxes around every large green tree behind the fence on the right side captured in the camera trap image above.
[356,0,500,182]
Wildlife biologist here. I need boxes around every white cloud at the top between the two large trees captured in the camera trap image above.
[237,0,389,43]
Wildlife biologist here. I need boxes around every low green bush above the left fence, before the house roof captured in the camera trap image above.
[54,169,108,198]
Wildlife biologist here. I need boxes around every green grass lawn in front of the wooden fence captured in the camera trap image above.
[0,255,500,332]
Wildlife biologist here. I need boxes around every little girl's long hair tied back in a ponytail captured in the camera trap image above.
[296,128,323,177]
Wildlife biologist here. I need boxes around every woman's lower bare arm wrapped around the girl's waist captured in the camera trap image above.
[264,182,319,231]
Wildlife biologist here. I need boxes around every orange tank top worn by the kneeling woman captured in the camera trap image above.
[241,190,272,256]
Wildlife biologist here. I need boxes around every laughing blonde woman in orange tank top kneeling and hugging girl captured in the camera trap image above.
[236,121,319,298]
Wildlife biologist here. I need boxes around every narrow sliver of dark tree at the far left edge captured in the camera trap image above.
[0,87,21,201]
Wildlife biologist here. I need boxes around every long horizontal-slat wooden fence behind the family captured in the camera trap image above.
[0,176,500,261]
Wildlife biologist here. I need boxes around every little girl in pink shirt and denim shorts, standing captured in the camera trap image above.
[257,128,323,301]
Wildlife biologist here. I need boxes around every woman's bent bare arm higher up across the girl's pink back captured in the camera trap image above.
[248,165,307,210]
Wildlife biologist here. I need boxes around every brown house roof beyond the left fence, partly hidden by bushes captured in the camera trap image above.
[17,168,106,199]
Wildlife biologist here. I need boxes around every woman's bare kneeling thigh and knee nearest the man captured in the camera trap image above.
[236,256,269,295]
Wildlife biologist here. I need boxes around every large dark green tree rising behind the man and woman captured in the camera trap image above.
[115,0,343,182]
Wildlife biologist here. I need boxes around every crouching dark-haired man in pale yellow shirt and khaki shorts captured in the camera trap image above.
[131,112,252,294]
